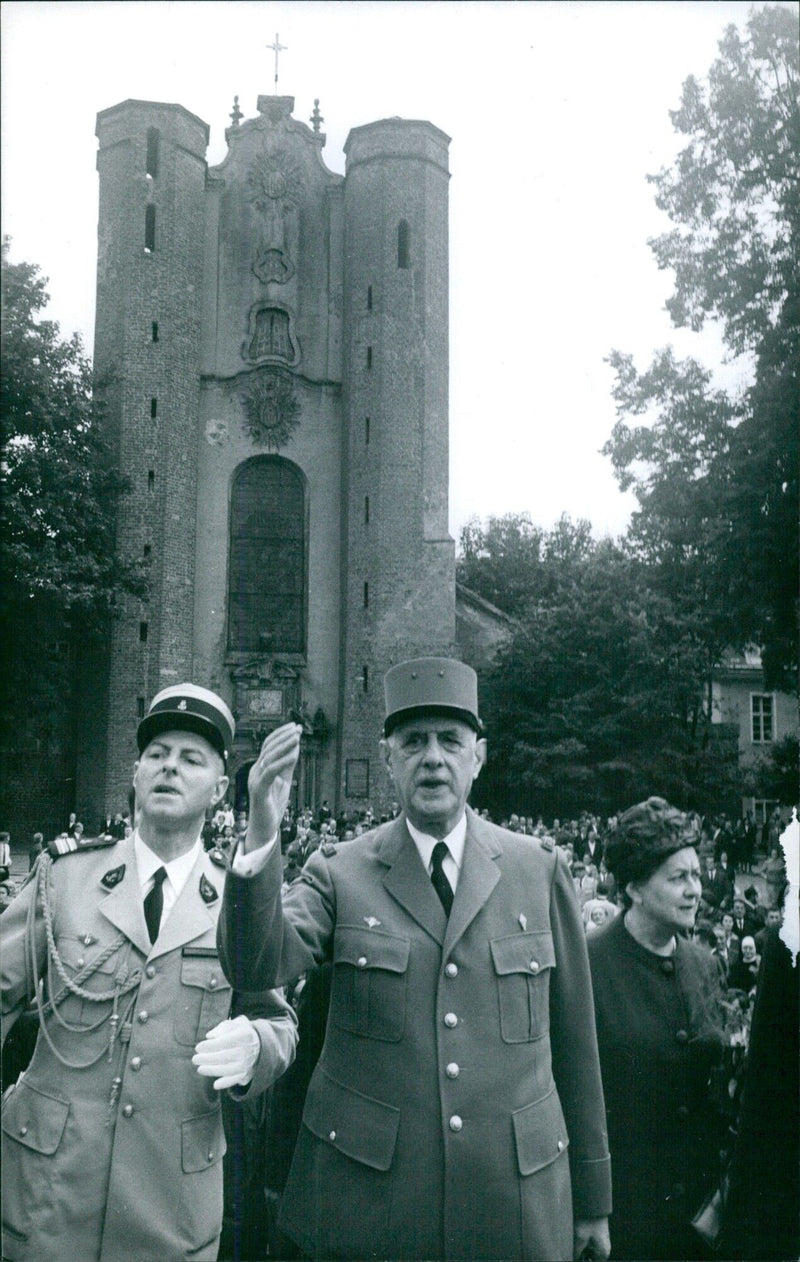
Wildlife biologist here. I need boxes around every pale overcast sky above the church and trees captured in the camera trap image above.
[1,0,767,538]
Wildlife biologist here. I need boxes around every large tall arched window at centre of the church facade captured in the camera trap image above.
[228,456,307,654]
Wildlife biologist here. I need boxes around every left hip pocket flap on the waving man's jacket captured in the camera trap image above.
[303,1070,400,1170]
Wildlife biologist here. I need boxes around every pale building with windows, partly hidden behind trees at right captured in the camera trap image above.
[712,647,800,824]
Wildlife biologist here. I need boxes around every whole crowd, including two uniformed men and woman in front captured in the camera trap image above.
[0,659,796,1262]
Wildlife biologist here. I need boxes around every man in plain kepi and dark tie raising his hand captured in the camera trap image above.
[220,658,611,1262]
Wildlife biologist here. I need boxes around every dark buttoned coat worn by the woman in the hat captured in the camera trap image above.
[588,915,723,1262]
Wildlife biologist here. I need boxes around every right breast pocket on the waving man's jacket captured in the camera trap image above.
[490,930,555,1042]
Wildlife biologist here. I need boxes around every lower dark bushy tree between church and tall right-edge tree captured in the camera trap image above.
[459,515,737,817]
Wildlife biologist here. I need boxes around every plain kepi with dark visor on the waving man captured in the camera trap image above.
[384,658,483,736]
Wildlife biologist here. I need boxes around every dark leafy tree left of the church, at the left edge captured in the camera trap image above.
[0,244,145,829]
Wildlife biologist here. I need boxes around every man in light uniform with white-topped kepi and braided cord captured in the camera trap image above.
[0,684,297,1262]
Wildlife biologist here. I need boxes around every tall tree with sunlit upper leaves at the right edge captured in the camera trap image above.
[604,6,800,688]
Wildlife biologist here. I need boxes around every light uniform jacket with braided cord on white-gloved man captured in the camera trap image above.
[0,837,297,1262]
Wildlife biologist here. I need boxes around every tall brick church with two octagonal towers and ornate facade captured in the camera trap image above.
[82,96,456,818]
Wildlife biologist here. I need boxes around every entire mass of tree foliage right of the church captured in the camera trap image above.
[458,6,800,815]
